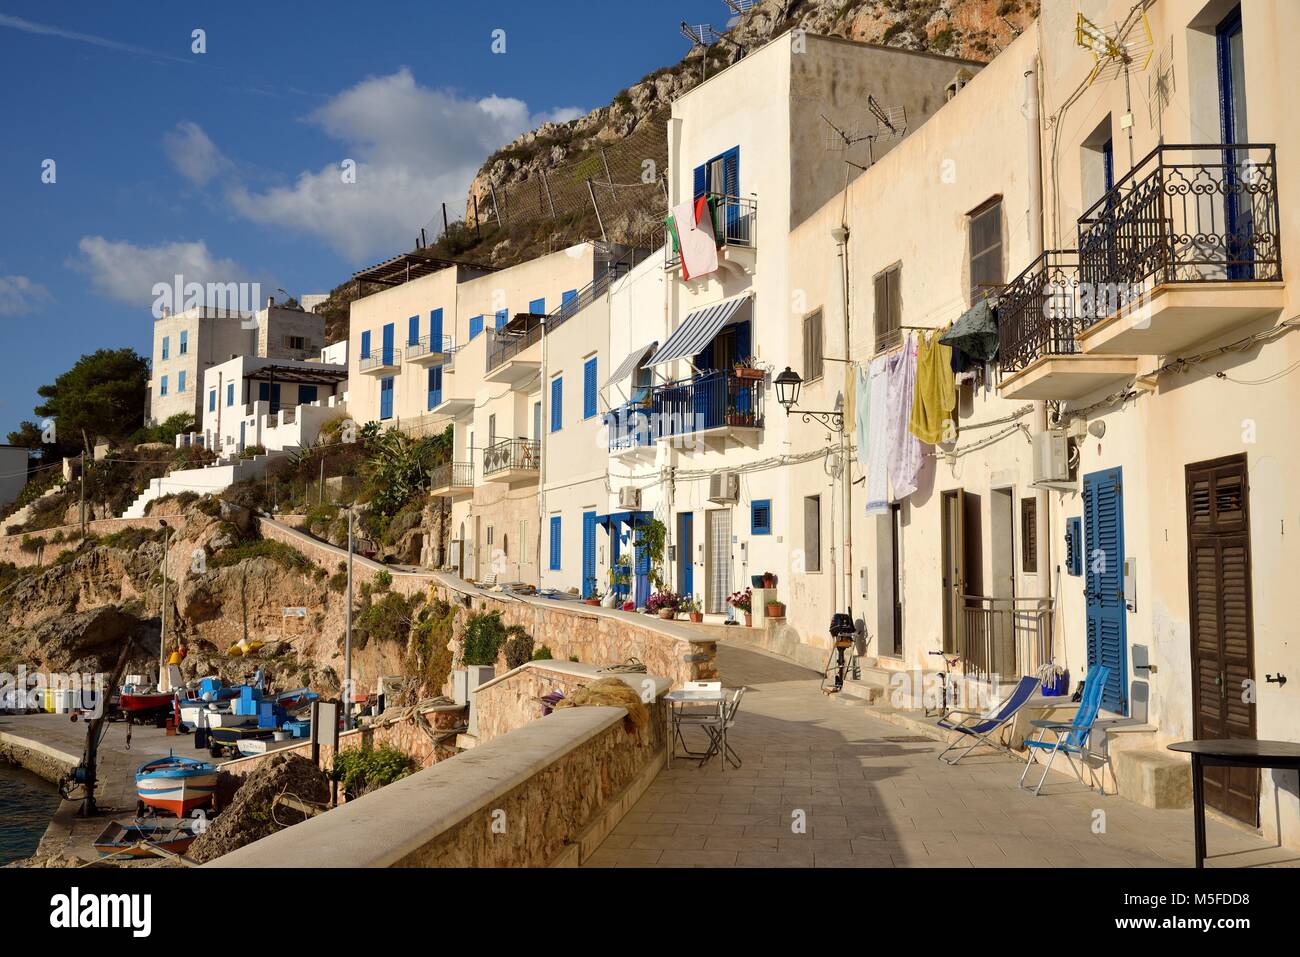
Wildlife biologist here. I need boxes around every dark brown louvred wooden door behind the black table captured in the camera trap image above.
[1187,455,1260,826]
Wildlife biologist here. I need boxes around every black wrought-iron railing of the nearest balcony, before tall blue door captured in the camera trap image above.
[1079,143,1282,314]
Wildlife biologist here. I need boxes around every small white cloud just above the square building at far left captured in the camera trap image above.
[69,235,265,307]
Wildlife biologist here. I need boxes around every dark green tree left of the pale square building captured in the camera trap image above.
[9,348,150,455]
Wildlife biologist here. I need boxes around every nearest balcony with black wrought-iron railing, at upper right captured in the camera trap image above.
[1079,144,1283,355]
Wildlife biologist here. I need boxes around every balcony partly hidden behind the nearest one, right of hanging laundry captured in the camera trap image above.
[997,250,1138,402]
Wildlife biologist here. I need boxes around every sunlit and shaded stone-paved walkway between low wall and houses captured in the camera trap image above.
[586,644,1300,867]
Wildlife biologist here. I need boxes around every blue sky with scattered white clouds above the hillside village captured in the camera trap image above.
[0,0,731,441]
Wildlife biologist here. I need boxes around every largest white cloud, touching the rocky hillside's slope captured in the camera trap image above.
[229,68,582,261]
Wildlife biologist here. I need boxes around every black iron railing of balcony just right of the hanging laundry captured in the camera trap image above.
[997,250,1087,376]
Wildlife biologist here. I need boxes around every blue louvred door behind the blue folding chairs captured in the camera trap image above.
[1083,468,1128,715]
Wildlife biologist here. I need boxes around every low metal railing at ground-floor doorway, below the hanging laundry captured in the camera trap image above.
[957,594,1053,680]
